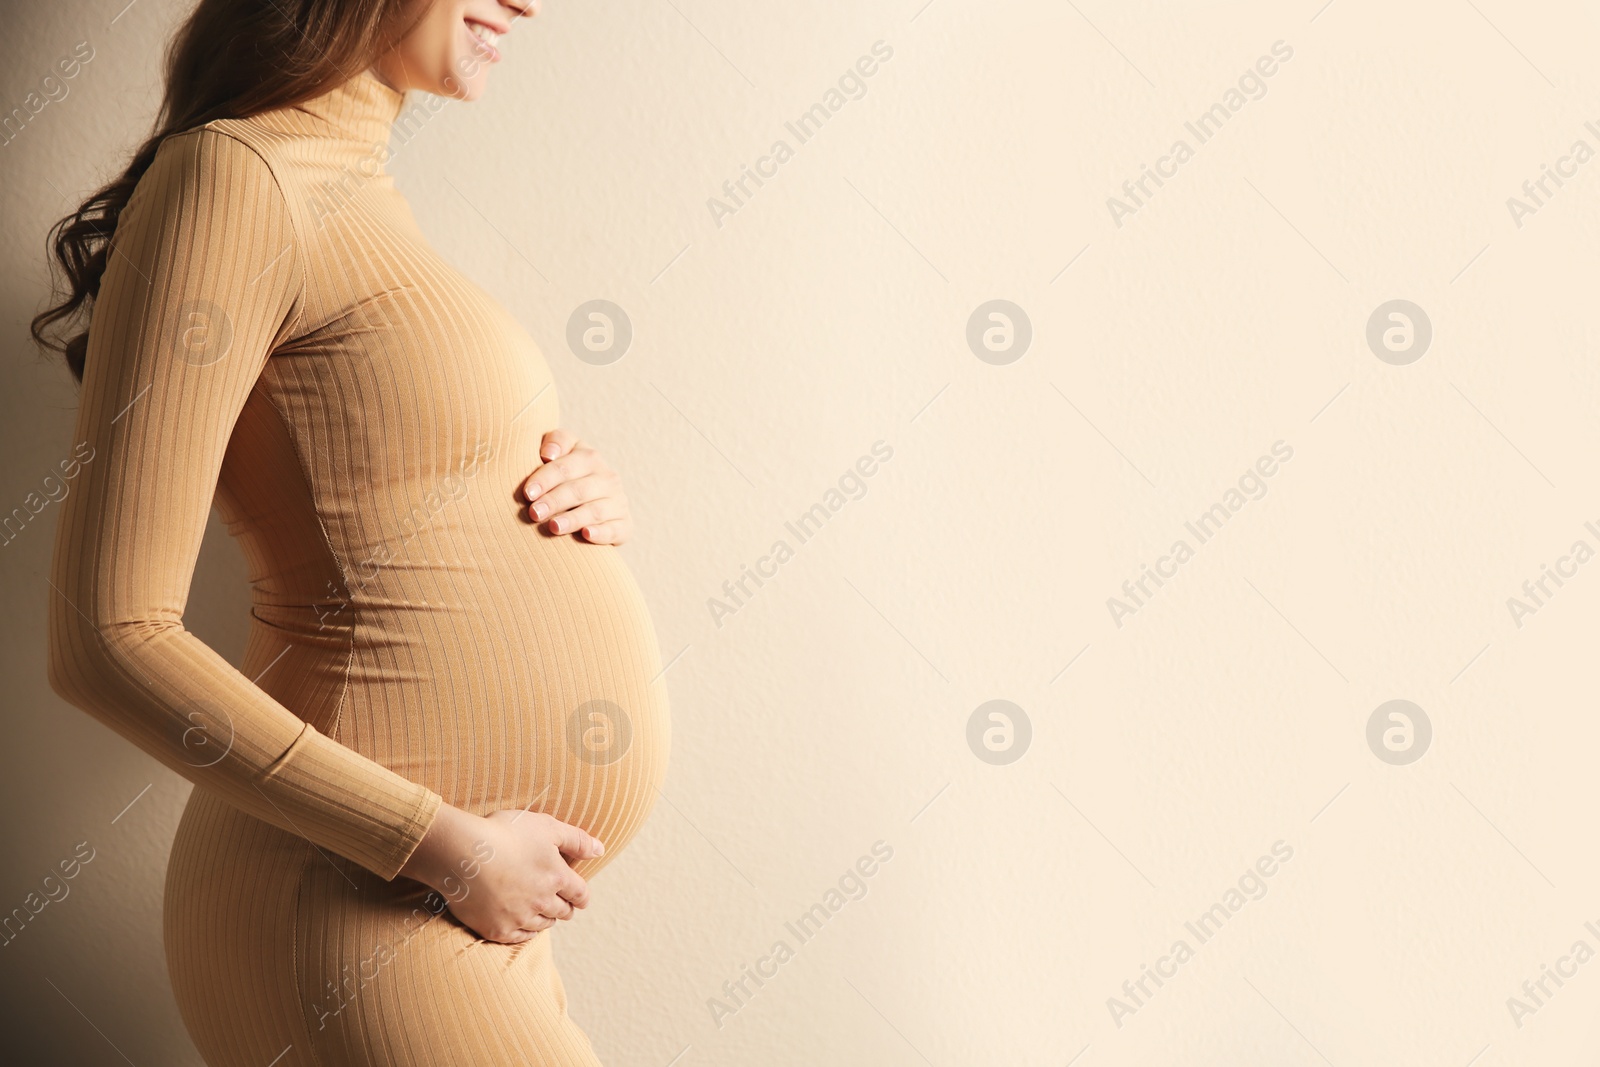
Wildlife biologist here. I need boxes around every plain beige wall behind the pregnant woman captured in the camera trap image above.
[0,0,1600,1067]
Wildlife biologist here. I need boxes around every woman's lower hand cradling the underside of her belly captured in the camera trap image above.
[400,803,605,944]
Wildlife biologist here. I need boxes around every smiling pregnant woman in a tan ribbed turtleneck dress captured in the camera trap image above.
[34,0,669,1067]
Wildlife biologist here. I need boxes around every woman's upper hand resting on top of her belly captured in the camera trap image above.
[517,429,634,544]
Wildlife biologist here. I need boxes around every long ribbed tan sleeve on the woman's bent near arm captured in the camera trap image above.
[48,128,442,880]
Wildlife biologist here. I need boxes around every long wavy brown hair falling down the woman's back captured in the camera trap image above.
[30,0,429,382]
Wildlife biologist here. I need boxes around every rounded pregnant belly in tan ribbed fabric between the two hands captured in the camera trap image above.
[338,520,670,873]
